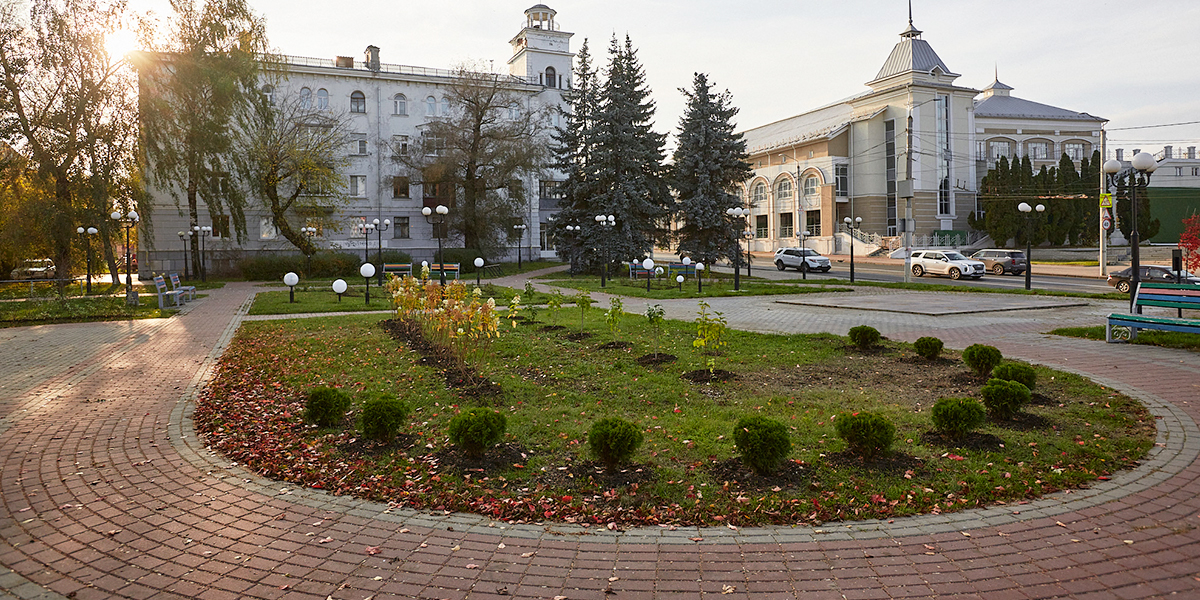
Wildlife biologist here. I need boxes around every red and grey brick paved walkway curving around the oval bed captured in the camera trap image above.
[0,281,1200,600]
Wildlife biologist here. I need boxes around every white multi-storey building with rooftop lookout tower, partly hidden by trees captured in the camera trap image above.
[138,5,574,274]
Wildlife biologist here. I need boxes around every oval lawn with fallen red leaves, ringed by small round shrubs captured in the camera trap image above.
[196,300,1156,527]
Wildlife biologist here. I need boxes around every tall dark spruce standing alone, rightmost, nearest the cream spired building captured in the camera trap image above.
[670,73,752,264]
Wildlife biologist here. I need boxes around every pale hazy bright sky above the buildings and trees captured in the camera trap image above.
[130,0,1200,157]
